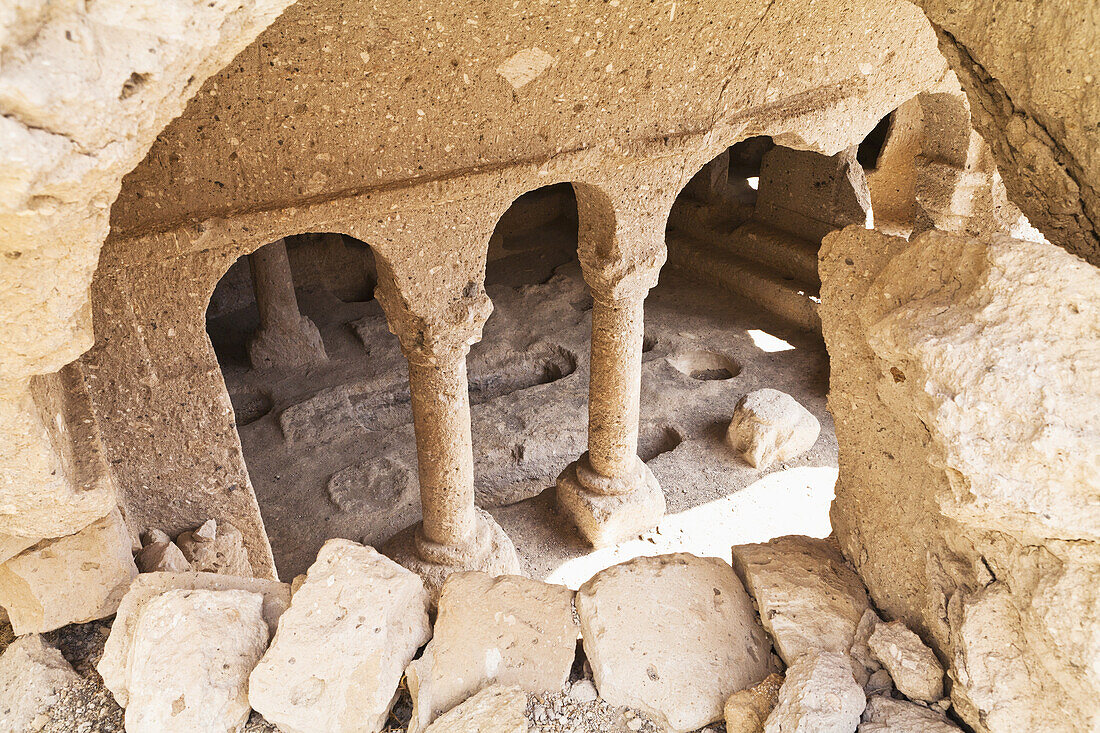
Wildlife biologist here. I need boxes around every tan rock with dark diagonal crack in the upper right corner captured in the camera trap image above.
[916,0,1100,264]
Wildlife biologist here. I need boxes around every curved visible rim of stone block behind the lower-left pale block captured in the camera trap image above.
[96,572,290,708]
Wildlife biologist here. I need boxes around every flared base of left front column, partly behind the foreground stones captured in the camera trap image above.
[382,510,524,608]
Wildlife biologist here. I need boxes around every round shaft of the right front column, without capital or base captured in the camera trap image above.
[589,295,645,479]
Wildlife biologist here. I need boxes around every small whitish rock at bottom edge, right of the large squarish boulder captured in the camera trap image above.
[763,652,867,733]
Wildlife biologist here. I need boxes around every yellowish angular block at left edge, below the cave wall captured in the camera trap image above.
[0,510,138,635]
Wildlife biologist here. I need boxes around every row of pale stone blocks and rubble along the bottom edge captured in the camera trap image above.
[0,533,959,733]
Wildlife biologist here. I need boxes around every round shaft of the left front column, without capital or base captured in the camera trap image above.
[409,355,476,546]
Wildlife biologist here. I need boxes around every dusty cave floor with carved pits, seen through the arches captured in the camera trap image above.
[210,214,837,586]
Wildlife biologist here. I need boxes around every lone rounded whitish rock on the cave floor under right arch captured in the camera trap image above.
[726,389,821,470]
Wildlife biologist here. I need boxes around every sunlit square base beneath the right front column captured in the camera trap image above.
[558,455,666,547]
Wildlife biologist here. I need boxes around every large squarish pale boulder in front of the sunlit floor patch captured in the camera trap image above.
[576,553,774,732]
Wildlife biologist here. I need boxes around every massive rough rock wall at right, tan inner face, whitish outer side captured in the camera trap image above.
[821,227,1100,732]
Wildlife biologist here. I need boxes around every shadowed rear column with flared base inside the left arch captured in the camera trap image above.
[249,239,328,369]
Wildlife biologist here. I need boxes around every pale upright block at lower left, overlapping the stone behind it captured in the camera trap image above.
[125,590,268,733]
